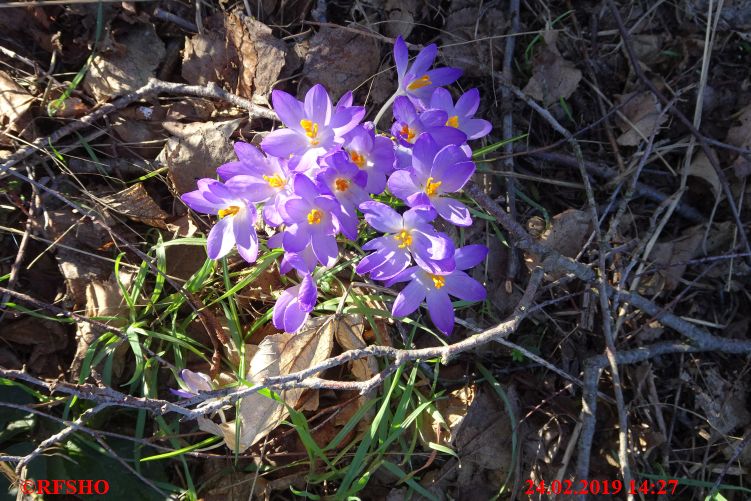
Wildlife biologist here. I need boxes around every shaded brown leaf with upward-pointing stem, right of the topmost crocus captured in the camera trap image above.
[524,32,582,106]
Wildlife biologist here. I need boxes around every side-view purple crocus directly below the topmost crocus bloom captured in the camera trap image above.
[391,96,467,147]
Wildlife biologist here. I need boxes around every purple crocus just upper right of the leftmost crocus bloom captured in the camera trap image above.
[216,141,292,226]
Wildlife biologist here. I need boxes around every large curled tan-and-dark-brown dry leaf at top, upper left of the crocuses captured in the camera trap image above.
[182,13,287,98]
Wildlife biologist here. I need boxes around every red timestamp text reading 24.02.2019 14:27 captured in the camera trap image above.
[524,479,678,496]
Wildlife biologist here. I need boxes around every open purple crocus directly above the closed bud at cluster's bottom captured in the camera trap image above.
[281,174,342,268]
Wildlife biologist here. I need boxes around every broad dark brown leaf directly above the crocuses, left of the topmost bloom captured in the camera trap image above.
[303,27,380,101]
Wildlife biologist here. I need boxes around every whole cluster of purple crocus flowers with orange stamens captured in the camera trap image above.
[182,38,491,334]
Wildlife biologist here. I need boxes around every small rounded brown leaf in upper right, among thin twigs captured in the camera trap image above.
[616,91,667,146]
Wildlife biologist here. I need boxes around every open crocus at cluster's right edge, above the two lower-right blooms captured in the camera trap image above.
[388,134,475,226]
